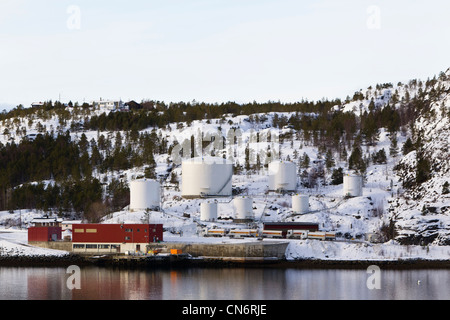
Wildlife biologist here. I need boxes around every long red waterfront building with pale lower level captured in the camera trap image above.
[72,224,163,253]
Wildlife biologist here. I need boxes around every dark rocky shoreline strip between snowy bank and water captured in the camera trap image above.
[0,254,450,270]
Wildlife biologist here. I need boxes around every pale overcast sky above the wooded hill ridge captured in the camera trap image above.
[0,0,450,109]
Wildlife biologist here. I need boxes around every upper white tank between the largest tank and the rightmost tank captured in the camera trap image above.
[269,161,297,191]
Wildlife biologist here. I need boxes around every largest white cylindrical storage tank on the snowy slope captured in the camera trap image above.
[181,157,233,198]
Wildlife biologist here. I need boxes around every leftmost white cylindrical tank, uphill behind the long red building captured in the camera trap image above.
[130,179,161,211]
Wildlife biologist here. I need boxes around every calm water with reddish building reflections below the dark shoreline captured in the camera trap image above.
[0,267,450,300]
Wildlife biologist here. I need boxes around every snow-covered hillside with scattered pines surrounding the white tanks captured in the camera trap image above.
[0,69,450,259]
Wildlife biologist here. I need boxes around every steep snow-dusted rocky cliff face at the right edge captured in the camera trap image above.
[390,70,450,245]
